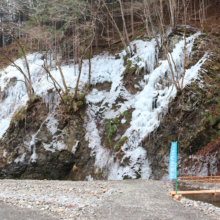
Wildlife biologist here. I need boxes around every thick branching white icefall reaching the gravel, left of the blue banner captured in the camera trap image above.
[86,33,207,180]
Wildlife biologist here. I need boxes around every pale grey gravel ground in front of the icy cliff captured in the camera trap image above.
[0,180,217,220]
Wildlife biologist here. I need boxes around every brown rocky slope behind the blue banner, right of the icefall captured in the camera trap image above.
[143,50,220,179]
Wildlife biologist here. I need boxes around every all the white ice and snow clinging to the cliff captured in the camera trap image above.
[0,33,206,179]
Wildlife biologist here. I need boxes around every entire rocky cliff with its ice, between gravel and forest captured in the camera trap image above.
[0,27,220,180]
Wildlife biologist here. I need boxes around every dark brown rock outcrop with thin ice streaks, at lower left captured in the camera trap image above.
[0,98,94,180]
